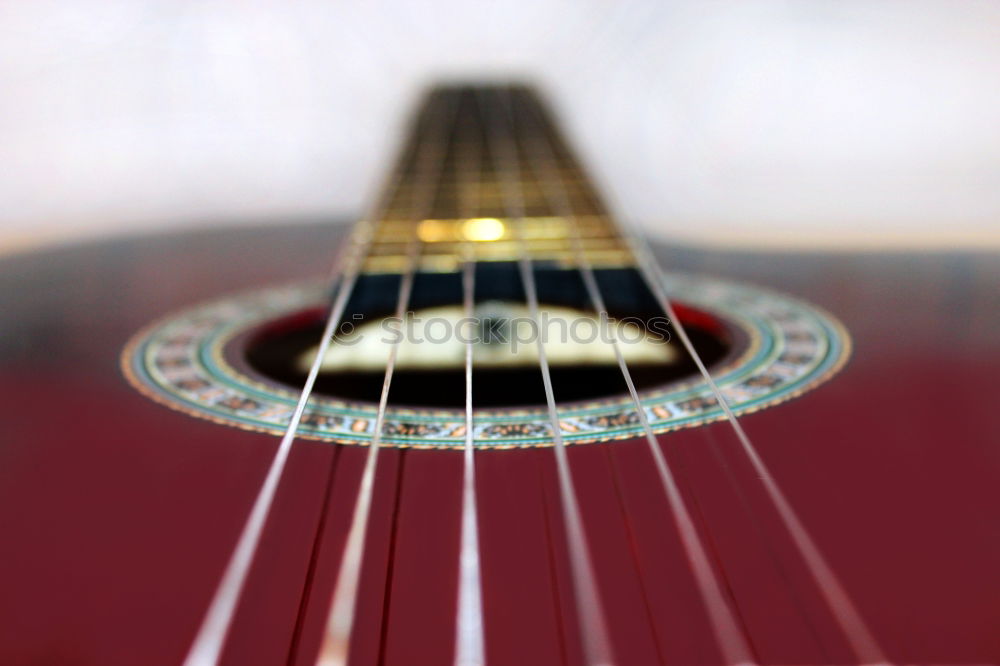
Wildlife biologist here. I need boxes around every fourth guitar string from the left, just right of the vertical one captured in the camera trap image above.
[484,85,614,665]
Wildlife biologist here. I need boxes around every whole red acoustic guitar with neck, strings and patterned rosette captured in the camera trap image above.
[0,86,1000,666]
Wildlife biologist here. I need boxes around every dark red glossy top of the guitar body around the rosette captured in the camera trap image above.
[0,225,1000,666]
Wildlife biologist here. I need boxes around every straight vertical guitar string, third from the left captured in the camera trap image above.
[454,91,486,666]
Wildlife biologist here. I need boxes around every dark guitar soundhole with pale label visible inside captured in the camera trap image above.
[244,265,734,409]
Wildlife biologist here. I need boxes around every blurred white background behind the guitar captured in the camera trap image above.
[0,0,1000,250]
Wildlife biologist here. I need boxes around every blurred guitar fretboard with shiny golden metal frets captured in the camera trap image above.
[363,87,633,273]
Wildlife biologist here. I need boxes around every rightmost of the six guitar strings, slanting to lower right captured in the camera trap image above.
[584,126,889,664]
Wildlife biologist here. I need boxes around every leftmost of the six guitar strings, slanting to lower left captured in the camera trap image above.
[183,96,438,666]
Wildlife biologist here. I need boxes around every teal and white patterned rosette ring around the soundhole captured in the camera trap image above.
[122,274,850,449]
